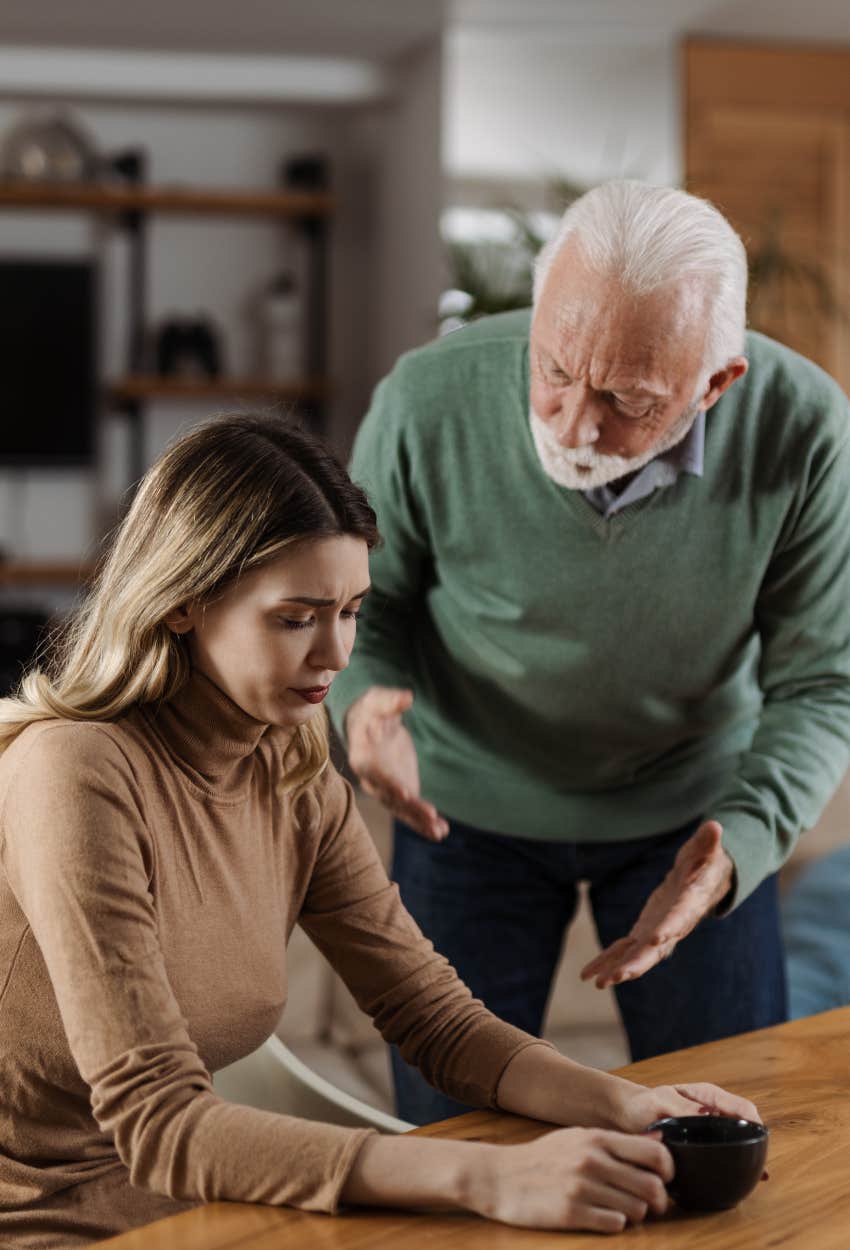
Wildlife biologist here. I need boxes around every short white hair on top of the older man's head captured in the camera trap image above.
[534,180,746,376]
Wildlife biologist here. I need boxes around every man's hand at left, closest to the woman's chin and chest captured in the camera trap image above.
[345,686,449,843]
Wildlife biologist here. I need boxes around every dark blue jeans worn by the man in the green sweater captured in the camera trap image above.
[393,821,788,1124]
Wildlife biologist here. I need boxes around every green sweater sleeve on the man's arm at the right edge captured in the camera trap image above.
[706,420,850,906]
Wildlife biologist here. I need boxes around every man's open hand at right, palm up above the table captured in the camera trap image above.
[581,820,734,990]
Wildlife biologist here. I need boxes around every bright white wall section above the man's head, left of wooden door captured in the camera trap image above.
[443,21,681,191]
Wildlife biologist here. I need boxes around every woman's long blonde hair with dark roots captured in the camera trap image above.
[0,414,379,798]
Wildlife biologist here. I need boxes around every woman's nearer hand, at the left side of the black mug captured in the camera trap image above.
[464,1130,670,1233]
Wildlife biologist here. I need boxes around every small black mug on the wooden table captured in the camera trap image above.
[646,1115,769,1211]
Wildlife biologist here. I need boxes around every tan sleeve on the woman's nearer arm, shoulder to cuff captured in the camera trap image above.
[1,725,370,1211]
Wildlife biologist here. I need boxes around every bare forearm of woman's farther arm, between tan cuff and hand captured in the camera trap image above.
[496,1046,643,1129]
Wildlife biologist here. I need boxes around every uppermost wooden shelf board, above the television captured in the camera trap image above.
[0,181,334,219]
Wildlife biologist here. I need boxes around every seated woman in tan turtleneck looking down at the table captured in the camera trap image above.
[0,416,756,1248]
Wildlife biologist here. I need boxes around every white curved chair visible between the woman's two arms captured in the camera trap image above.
[213,1036,414,1133]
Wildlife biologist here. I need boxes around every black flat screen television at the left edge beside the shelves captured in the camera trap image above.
[0,258,98,468]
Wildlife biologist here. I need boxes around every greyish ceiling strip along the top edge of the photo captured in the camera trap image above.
[0,0,850,61]
